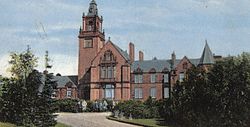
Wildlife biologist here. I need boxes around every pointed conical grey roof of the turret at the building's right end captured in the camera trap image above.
[199,40,214,65]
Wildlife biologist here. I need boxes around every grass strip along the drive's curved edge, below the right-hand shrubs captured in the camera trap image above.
[107,117,169,127]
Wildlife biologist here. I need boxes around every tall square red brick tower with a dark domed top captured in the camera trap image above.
[78,0,105,99]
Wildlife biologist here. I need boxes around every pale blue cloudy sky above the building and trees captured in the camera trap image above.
[0,0,250,75]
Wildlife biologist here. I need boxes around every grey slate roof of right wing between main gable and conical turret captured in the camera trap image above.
[131,59,200,72]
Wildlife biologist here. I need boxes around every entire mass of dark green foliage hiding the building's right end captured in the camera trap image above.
[164,53,250,127]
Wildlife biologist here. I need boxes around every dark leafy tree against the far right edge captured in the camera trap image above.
[209,53,250,127]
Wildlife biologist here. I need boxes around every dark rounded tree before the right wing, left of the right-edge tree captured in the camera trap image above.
[171,67,211,127]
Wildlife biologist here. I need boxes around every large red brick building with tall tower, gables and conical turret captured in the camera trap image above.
[76,0,217,100]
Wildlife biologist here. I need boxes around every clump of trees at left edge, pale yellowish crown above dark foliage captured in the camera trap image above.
[0,50,56,126]
